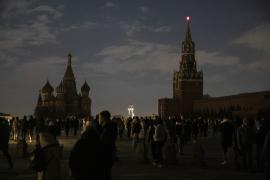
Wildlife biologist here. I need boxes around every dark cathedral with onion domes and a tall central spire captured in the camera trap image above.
[34,53,92,118]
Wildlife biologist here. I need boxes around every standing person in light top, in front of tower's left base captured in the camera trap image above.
[153,118,167,168]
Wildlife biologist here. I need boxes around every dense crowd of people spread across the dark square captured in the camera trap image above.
[0,111,270,180]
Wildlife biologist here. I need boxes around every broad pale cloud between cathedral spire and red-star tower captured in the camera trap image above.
[84,40,177,74]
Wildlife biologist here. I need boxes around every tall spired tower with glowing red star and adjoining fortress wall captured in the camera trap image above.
[158,19,270,118]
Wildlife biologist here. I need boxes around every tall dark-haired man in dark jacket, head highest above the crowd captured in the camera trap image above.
[98,111,117,180]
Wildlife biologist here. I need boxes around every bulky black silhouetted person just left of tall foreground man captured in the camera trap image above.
[69,121,102,180]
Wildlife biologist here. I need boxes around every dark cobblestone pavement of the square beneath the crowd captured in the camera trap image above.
[0,136,264,180]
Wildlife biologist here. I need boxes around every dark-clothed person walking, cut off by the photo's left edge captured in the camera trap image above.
[0,117,13,169]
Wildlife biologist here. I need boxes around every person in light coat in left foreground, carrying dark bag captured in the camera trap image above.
[36,130,61,180]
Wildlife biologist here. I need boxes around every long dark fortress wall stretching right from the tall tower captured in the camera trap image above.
[193,91,270,117]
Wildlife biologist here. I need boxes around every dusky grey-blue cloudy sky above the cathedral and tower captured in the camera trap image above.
[0,0,270,116]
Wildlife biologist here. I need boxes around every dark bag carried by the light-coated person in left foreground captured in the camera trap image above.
[30,148,46,172]
